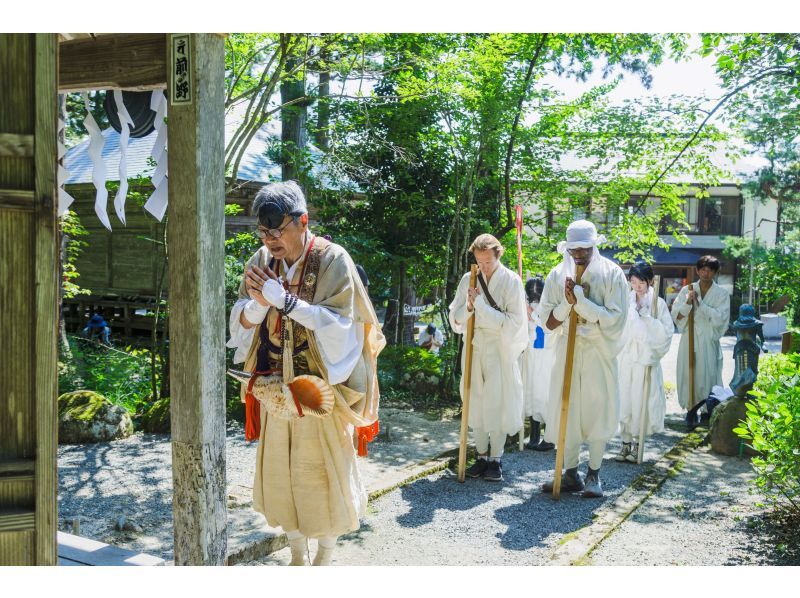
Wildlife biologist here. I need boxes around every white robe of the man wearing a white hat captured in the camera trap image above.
[541,251,629,446]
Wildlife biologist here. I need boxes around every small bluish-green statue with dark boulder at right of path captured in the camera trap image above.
[709,303,764,456]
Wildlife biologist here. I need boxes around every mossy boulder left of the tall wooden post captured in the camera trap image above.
[58,390,133,444]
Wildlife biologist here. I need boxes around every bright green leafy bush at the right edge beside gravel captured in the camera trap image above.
[734,353,800,514]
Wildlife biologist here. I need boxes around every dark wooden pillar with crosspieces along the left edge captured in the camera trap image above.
[0,33,58,565]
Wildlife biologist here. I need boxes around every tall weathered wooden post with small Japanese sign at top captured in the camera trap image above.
[167,33,227,565]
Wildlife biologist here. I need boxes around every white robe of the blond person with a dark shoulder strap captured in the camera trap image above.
[450,264,528,434]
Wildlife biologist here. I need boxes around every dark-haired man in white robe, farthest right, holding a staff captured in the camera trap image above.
[672,255,731,428]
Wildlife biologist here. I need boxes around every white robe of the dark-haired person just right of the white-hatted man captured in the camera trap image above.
[619,288,675,437]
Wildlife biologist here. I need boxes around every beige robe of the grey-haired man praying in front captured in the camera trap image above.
[229,237,386,538]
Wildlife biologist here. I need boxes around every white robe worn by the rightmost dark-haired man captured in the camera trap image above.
[672,282,731,409]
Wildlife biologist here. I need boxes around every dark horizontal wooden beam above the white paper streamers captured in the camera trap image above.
[58,33,167,93]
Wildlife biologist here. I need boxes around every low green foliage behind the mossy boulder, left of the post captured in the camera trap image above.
[58,336,162,414]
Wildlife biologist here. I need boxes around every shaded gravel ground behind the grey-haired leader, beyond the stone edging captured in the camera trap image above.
[58,408,459,561]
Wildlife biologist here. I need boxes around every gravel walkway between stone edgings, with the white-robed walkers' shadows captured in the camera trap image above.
[250,429,682,565]
